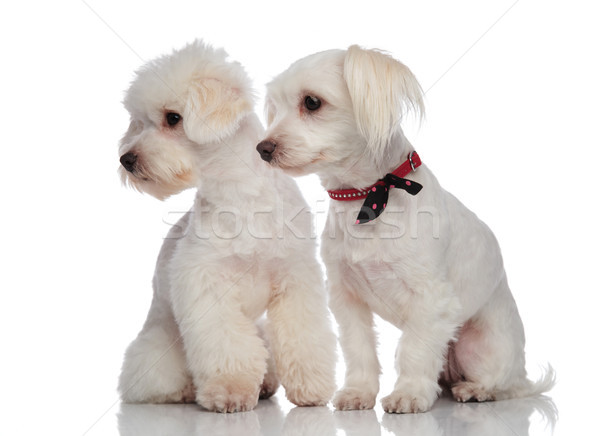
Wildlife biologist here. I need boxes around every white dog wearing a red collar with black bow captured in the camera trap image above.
[257,46,554,413]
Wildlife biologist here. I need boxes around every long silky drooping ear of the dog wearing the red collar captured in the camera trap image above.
[344,45,424,158]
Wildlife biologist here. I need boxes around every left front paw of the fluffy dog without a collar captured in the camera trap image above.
[196,375,260,413]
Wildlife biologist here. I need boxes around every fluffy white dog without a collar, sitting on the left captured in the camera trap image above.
[119,41,335,412]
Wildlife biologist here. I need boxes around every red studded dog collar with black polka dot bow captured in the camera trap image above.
[327,151,423,224]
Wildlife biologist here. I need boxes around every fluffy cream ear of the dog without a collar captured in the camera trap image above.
[183,78,253,144]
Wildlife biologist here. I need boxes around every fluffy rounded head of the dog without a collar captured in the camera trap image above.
[119,41,254,199]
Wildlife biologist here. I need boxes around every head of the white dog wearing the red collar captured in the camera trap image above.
[257,46,423,175]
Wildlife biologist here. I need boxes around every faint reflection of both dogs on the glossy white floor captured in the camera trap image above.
[118,396,557,436]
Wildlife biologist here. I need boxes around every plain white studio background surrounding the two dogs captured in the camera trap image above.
[0,0,600,435]
